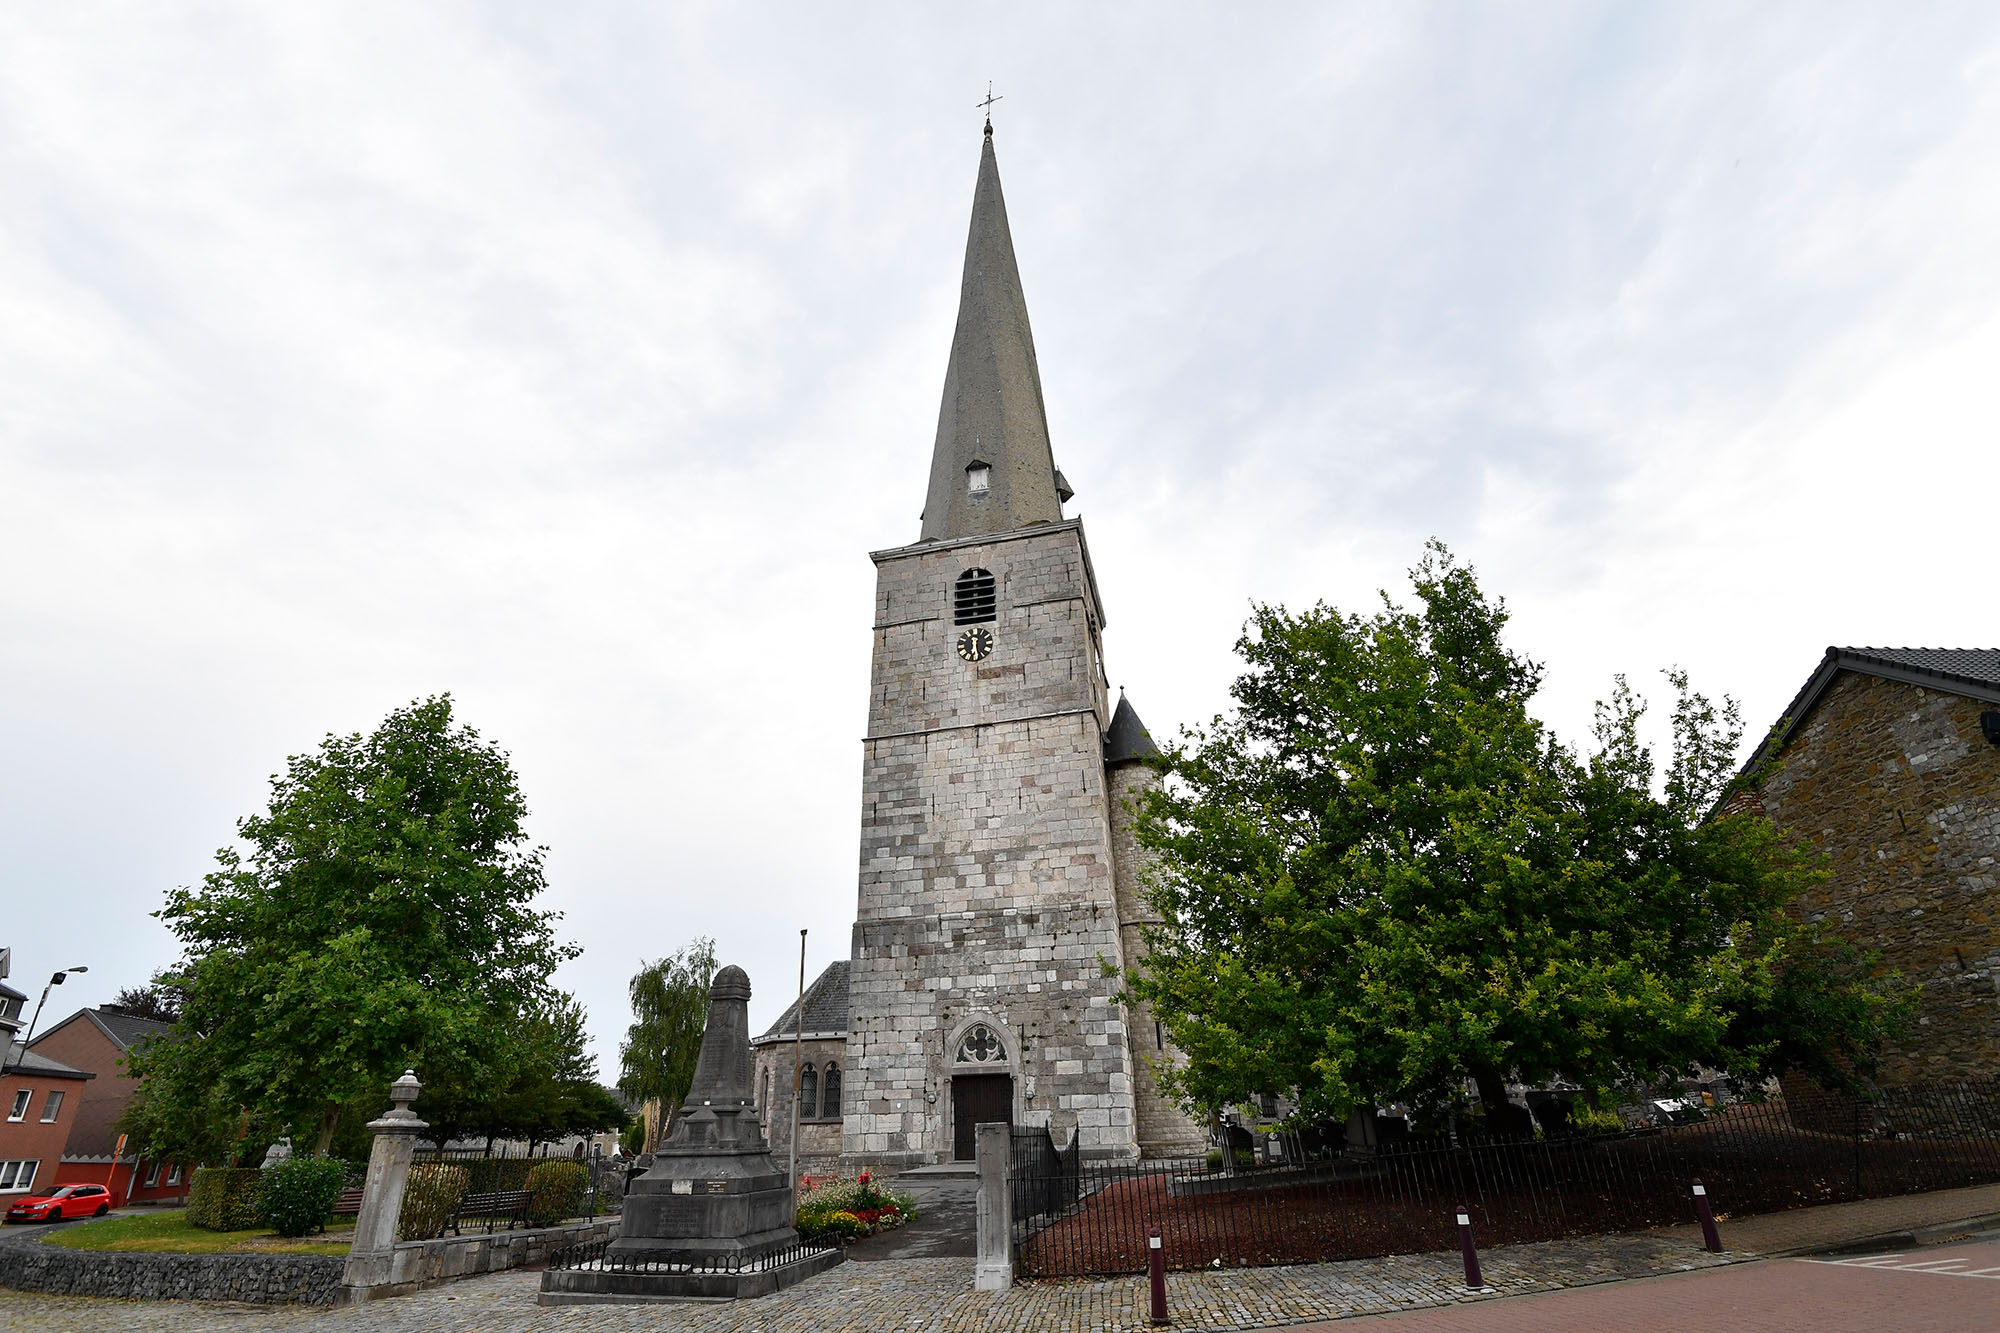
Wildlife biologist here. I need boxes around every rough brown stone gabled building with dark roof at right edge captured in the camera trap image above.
[1748,648,2000,1085]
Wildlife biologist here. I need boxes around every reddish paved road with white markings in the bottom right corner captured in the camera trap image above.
[1306,1239,2000,1333]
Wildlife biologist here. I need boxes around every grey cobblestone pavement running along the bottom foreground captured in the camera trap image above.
[0,1233,1742,1333]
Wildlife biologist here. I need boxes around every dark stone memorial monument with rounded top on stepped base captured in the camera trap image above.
[540,967,842,1305]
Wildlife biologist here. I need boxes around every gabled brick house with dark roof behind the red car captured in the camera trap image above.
[32,1005,182,1203]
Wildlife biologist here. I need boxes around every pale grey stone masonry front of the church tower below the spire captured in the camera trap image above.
[844,522,1138,1165]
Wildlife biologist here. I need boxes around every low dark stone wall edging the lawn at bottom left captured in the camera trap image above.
[0,1235,342,1305]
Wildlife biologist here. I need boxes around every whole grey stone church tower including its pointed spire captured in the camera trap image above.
[842,124,1192,1169]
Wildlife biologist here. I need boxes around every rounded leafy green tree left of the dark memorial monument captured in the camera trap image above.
[134,695,578,1151]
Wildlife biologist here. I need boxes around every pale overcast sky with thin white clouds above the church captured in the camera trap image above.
[0,0,2000,1077]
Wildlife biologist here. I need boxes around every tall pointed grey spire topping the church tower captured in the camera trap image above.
[922,124,1070,542]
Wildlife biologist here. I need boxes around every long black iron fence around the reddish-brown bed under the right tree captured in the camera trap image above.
[1012,1085,2000,1277]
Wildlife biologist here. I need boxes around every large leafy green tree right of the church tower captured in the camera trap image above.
[1128,542,1904,1117]
